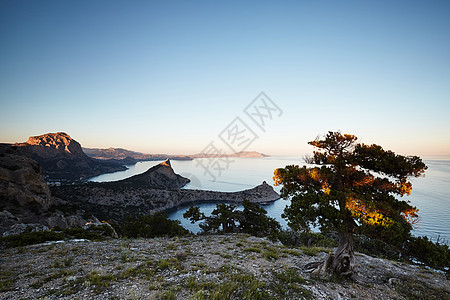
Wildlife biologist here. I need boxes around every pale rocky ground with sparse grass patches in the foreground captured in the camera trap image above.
[0,234,450,299]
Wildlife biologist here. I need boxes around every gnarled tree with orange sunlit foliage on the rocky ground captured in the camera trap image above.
[274,132,427,276]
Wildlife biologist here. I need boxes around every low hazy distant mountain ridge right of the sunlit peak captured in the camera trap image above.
[83,148,192,161]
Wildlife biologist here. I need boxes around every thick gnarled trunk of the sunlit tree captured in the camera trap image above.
[331,232,355,276]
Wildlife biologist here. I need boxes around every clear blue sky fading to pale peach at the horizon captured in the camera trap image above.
[0,0,450,155]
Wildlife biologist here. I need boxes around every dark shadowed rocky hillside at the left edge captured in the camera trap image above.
[0,144,91,235]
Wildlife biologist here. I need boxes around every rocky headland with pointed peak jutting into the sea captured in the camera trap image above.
[51,160,280,222]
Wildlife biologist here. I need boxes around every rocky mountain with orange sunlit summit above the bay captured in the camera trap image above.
[14,132,126,181]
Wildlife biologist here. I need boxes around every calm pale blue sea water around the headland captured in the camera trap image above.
[91,157,450,242]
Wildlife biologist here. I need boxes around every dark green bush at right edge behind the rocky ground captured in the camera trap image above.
[406,237,450,272]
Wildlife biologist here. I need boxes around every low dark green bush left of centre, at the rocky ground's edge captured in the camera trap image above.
[121,212,189,238]
